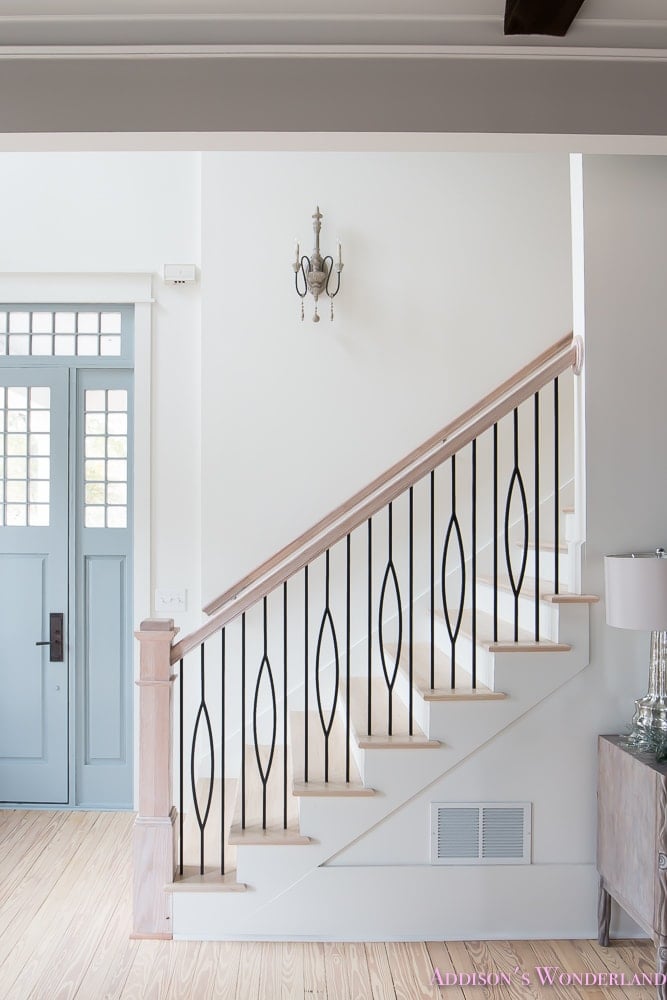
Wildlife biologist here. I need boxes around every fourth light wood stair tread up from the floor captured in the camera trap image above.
[350,677,440,749]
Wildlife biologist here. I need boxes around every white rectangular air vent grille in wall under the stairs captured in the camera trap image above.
[431,802,531,865]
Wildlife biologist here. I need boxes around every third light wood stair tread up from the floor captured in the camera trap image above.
[290,712,375,796]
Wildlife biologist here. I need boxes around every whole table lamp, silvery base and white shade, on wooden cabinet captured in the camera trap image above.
[604,549,667,738]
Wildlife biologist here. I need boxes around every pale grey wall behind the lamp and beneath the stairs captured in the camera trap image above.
[328,156,667,935]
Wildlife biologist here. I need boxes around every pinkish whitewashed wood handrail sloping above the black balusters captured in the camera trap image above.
[171,333,581,663]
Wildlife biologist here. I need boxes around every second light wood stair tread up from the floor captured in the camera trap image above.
[229,744,310,844]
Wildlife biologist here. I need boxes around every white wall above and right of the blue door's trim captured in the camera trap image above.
[0,153,201,626]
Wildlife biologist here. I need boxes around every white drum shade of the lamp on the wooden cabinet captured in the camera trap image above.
[604,552,667,632]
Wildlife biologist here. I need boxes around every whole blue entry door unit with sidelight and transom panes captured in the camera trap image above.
[0,304,134,808]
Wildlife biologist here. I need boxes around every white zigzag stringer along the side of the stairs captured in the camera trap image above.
[173,604,589,940]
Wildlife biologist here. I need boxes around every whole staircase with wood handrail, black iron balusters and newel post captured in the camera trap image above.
[135,337,597,940]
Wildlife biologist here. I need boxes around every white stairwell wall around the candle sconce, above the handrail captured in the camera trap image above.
[202,153,571,599]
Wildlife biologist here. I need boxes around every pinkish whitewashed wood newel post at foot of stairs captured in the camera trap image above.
[132,618,178,938]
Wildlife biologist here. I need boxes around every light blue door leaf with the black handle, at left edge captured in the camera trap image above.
[0,367,69,803]
